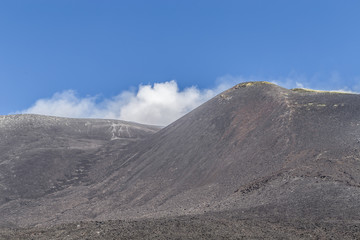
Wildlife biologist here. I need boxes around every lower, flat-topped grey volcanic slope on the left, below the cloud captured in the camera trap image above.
[0,115,159,212]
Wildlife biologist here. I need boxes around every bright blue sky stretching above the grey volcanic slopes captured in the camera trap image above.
[0,0,360,124]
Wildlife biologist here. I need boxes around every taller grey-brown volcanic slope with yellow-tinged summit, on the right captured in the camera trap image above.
[0,82,360,232]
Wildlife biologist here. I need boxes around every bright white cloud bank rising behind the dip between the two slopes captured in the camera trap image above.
[21,80,231,125]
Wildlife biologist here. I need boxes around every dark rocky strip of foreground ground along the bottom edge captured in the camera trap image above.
[0,212,360,240]
